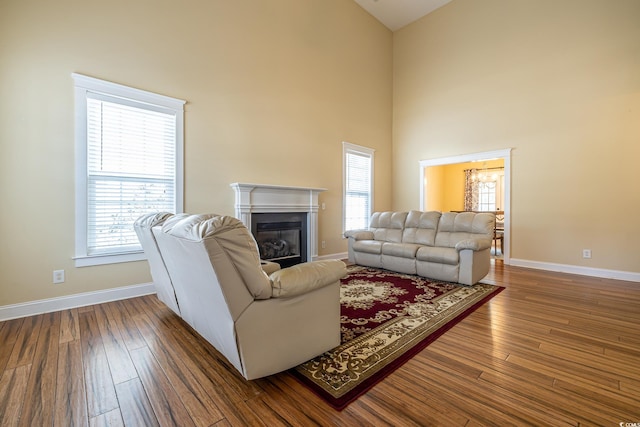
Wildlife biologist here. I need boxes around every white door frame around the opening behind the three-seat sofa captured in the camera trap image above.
[419,148,512,265]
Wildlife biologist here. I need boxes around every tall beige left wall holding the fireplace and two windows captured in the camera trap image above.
[0,0,392,306]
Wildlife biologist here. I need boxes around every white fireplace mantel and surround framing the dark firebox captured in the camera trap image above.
[231,182,327,261]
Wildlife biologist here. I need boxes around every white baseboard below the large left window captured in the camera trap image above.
[0,283,156,321]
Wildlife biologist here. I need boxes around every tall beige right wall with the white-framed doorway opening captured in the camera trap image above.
[393,0,640,272]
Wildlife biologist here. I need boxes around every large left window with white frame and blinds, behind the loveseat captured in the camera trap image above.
[72,74,185,267]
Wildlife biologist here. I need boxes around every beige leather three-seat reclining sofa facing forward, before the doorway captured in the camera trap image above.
[345,211,495,285]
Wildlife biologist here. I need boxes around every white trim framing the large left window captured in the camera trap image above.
[71,73,186,267]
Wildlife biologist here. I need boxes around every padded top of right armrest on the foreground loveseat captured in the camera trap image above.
[269,259,347,298]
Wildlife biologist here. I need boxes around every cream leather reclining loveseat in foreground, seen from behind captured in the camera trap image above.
[135,214,346,380]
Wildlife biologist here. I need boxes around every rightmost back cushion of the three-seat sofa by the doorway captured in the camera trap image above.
[435,212,495,248]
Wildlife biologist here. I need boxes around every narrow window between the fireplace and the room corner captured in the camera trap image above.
[342,142,374,231]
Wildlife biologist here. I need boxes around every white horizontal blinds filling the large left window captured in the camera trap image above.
[87,93,176,255]
